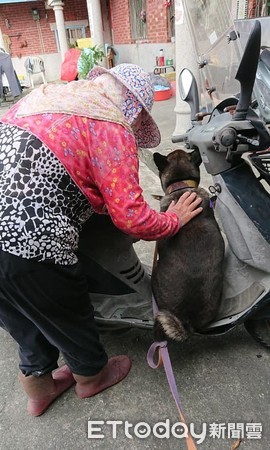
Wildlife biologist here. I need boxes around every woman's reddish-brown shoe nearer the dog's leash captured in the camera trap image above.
[73,355,132,398]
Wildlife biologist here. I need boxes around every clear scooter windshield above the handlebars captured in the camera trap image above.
[184,0,243,112]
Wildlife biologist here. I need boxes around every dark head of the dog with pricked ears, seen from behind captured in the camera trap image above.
[153,150,202,192]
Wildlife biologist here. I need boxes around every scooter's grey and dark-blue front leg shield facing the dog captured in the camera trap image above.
[198,142,270,334]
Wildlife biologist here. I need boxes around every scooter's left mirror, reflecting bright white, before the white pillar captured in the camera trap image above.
[179,69,199,122]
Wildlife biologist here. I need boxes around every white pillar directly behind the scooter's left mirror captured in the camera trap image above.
[173,0,199,135]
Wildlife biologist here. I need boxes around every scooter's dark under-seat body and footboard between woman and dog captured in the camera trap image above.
[79,214,153,328]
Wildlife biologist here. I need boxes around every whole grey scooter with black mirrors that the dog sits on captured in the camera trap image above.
[79,22,270,346]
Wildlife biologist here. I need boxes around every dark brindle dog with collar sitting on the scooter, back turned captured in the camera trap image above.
[152,150,224,341]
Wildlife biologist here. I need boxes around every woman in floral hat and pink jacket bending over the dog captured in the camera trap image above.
[0,64,202,416]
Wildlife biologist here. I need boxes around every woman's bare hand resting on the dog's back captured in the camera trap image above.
[167,192,203,227]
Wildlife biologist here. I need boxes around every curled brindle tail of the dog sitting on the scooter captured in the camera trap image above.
[156,311,191,342]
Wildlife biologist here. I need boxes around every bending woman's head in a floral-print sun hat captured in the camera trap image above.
[88,64,160,148]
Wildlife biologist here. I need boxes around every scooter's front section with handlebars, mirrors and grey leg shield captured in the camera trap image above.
[173,21,270,346]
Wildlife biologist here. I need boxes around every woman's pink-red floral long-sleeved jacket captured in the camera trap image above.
[1,102,180,240]
